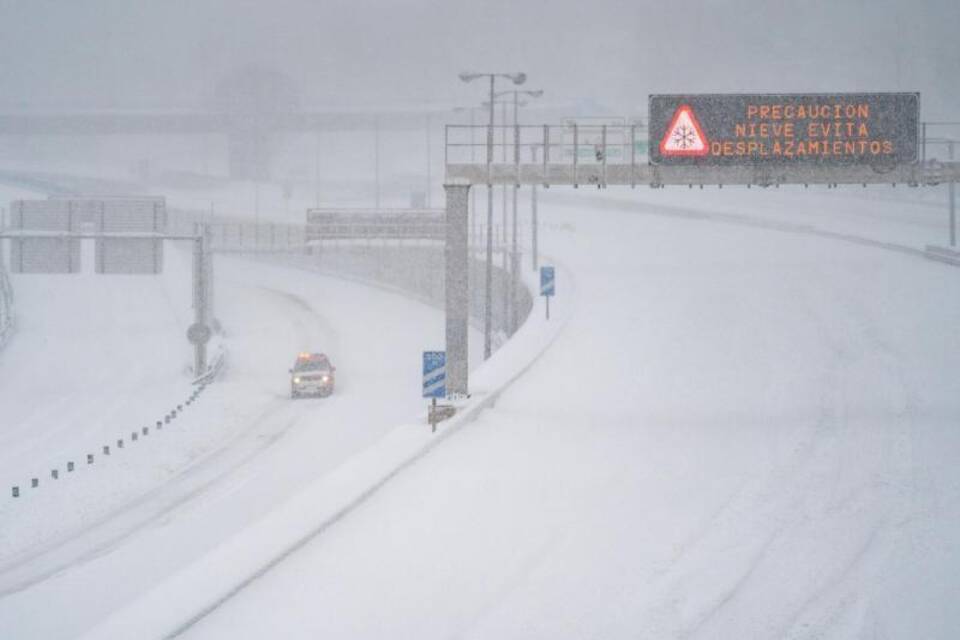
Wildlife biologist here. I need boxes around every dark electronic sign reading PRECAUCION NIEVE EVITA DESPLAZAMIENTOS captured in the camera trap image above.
[649,93,920,170]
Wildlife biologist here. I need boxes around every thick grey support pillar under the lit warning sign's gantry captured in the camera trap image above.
[443,184,470,397]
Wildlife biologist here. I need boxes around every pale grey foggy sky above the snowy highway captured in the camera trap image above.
[0,0,960,119]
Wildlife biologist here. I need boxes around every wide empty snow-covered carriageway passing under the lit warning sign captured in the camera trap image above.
[169,194,960,638]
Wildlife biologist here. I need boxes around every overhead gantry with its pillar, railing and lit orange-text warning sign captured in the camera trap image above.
[444,93,960,396]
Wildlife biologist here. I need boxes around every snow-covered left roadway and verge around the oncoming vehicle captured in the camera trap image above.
[0,250,476,638]
